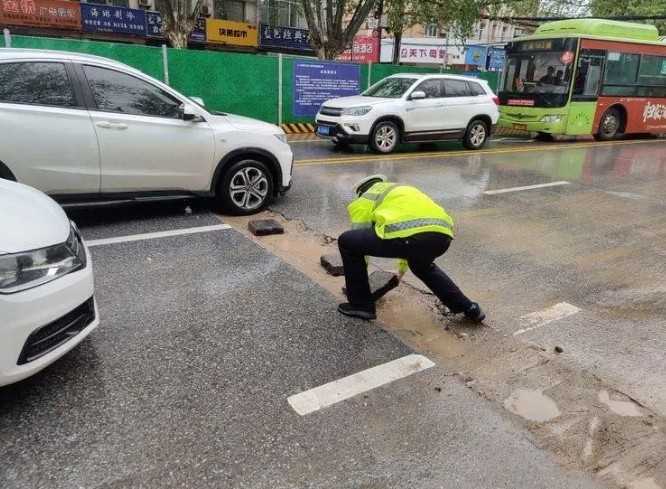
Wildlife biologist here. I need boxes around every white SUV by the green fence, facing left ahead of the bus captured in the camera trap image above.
[316,74,499,153]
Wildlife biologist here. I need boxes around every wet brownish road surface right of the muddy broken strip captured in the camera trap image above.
[274,135,666,414]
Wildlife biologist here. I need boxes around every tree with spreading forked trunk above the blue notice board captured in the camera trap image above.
[301,0,375,59]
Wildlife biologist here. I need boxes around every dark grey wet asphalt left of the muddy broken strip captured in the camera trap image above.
[0,202,596,489]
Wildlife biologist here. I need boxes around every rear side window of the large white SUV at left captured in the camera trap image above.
[0,63,77,107]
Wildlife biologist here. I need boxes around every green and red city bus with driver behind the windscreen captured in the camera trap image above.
[498,19,666,140]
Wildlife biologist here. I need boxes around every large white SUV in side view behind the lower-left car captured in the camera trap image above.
[0,49,293,214]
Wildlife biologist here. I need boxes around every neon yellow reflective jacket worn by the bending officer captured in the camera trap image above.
[347,182,453,239]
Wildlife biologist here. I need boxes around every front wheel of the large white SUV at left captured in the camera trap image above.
[215,158,274,216]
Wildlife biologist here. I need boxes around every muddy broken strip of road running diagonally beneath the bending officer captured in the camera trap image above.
[225,212,666,489]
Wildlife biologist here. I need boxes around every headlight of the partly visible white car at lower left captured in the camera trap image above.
[0,223,86,294]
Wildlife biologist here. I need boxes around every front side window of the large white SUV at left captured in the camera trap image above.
[83,66,182,119]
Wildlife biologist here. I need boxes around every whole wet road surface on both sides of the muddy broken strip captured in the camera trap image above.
[0,134,666,489]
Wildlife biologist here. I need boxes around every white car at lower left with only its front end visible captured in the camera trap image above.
[0,179,99,386]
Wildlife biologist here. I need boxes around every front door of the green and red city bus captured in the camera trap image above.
[566,49,606,135]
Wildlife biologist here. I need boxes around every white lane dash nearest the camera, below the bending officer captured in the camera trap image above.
[287,353,435,416]
